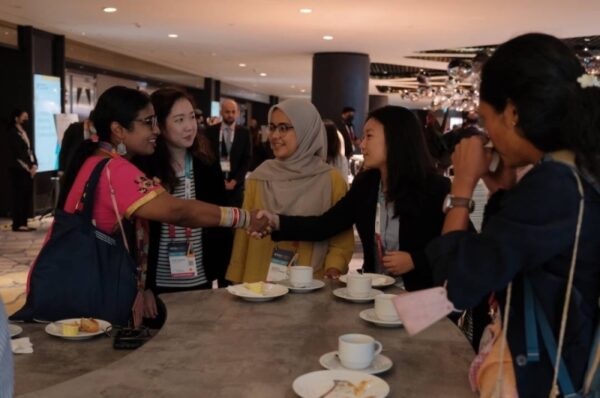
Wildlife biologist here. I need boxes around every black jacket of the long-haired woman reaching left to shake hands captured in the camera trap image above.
[272,170,450,290]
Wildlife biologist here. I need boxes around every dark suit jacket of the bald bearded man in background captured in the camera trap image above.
[206,123,252,188]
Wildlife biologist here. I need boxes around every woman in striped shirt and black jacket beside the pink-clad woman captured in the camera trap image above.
[139,88,233,323]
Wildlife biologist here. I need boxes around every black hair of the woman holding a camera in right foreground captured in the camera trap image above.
[480,33,600,179]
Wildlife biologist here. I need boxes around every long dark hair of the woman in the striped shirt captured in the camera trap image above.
[148,87,216,190]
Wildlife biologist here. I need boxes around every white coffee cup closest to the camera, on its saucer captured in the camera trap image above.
[338,333,383,369]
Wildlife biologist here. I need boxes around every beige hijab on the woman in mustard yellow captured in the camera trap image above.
[249,99,332,271]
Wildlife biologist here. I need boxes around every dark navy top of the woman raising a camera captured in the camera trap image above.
[427,161,600,398]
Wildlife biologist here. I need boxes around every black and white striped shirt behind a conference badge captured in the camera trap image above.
[156,168,208,288]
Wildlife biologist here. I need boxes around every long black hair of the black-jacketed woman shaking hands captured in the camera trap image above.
[367,105,434,215]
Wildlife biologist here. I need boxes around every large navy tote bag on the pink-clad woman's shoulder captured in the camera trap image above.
[10,159,137,326]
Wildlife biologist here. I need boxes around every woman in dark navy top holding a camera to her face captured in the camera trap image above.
[427,34,600,397]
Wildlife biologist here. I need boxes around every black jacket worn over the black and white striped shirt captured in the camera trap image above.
[146,157,233,290]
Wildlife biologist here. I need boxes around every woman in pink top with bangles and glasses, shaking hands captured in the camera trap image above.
[59,86,264,324]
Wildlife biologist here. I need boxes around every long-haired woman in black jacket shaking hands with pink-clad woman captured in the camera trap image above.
[269,106,450,290]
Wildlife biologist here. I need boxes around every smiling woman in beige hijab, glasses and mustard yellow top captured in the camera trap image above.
[226,99,354,282]
